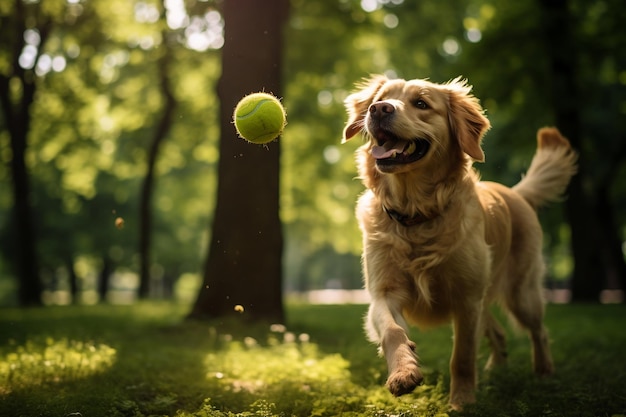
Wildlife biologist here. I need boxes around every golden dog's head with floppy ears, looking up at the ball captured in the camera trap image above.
[343,76,490,173]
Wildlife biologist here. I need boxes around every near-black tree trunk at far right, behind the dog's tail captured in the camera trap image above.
[539,0,626,302]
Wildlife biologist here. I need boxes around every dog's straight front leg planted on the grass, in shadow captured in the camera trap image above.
[450,302,482,410]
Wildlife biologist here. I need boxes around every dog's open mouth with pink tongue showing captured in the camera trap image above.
[371,129,430,165]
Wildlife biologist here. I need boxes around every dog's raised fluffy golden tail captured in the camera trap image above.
[513,127,578,209]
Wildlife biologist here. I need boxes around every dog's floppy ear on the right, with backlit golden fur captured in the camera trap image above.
[446,77,491,162]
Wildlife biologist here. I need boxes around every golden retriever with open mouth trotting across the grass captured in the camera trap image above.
[342,76,577,410]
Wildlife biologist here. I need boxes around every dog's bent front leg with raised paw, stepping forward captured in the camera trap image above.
[367,299,423,396]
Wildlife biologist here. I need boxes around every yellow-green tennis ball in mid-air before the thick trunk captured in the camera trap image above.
[233,93,287,144]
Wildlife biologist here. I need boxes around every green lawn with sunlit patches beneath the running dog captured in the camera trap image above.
[0,302,626,417]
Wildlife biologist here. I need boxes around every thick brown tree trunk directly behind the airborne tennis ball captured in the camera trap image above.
[190,0,288,321]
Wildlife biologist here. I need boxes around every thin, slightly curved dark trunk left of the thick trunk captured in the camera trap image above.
[138,6,176,299]
